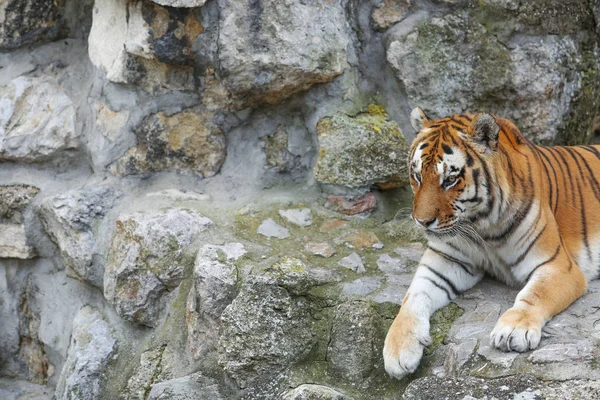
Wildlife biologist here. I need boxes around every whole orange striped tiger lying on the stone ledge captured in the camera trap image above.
[383,107,600,379]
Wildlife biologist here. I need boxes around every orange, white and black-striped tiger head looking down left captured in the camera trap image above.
[409,107,500,234]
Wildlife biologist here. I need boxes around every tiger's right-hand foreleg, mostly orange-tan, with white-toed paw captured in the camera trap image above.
[490,245,587,352]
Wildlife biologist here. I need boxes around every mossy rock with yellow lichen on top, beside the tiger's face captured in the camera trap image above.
[313,105,409,189]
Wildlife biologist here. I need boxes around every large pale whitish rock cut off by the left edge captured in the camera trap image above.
[0,76,79,162]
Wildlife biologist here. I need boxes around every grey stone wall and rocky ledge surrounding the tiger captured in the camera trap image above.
[0,0,600,400]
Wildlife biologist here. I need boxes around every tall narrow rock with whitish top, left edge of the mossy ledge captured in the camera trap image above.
[186,243,246,358]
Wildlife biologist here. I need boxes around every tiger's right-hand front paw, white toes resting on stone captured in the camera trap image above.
[490,308,543,353]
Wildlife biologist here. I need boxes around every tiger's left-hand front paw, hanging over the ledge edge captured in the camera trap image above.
[383,317,431,379]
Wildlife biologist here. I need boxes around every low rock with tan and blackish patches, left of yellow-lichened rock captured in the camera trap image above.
[109,110,227,178]
